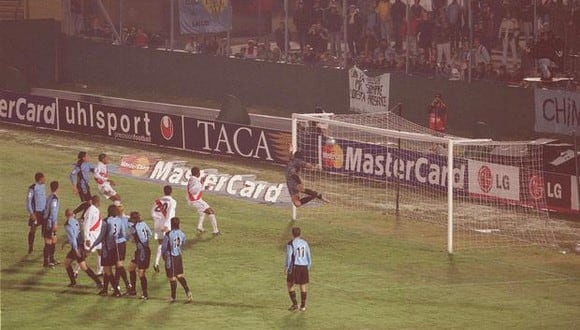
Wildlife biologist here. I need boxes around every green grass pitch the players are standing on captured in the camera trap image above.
[0,125,580,329]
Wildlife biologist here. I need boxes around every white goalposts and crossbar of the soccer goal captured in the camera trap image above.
[291,113,492,254]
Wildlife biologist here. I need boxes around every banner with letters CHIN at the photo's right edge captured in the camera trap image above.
[534,88,580,136]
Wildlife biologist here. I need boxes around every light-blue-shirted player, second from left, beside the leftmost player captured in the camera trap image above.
[42,181,60,267]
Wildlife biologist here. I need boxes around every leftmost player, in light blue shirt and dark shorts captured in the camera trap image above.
[26,172,46,254]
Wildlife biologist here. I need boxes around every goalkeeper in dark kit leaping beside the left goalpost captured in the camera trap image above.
[286,151,329,207]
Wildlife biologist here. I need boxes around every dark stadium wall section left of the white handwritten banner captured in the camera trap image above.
[63,39,348,116]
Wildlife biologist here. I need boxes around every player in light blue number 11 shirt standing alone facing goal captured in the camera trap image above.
[284,227,312,312]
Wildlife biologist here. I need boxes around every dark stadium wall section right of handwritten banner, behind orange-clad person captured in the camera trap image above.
[390,73,538,140]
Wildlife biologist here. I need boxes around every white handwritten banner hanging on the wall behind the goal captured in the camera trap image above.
[348,67,390,113]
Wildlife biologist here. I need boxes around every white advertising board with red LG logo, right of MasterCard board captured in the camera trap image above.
[467,160,520,202]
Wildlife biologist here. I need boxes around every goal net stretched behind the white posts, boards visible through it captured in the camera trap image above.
[292,112,580,253]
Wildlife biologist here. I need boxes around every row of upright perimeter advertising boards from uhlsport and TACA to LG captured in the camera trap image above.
[0,90,580,217]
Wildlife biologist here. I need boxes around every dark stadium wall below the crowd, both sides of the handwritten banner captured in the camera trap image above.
[63,39,537,139]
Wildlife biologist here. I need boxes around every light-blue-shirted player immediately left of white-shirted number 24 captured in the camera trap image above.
[128,212,153,300]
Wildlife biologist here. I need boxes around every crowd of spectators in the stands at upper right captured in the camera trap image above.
[256,0,580,80]
